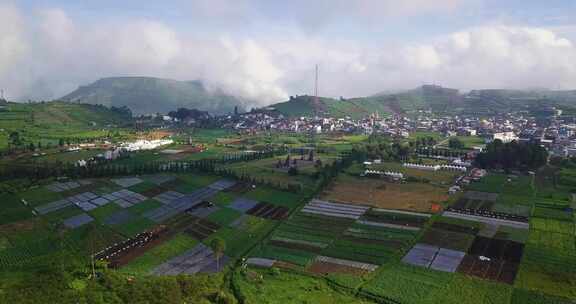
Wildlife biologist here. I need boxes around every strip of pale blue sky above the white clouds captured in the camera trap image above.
[18,0,576,39]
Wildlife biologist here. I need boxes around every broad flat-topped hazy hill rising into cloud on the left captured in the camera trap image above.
[61,77,246,114]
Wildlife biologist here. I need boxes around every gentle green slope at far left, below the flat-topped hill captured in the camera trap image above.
[0,102,131,150]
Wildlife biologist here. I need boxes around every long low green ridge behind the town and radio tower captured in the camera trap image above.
[270,85,576,118]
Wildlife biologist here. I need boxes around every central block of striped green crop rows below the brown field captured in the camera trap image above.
[250,200,428,274]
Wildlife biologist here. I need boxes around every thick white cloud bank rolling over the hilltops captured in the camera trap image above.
[0,0,576,105]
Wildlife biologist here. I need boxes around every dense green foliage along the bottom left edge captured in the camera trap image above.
[0,265,236,304]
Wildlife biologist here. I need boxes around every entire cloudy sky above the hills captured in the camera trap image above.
[0,0,576,105]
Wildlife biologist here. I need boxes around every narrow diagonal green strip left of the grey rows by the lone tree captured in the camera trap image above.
[121,233,198,274]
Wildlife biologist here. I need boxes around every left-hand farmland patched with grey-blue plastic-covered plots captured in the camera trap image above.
[0,175,245,268]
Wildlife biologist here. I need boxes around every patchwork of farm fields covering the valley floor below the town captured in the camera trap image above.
[0,119,576,304]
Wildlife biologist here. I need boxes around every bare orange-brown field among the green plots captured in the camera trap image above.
[322,175,448,212]
